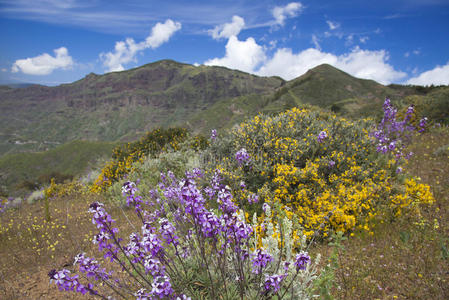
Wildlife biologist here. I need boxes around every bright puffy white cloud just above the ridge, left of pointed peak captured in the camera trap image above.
[204,36,266,73]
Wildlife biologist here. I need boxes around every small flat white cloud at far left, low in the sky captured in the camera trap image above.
[11,47,73,75]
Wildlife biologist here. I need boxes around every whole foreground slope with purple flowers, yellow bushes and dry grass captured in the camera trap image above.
[0,98,449,299]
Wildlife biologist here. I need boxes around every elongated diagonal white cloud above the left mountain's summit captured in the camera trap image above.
[100,19,181,72]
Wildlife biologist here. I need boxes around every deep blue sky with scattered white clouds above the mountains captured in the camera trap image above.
[0,0,449,85]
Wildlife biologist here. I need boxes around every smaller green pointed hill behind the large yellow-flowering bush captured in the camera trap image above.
[184,64,404,131]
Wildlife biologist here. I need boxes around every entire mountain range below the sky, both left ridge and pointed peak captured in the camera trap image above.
[0,60,447,156]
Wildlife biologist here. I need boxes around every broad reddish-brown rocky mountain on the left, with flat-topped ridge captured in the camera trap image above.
[0,60,284,155]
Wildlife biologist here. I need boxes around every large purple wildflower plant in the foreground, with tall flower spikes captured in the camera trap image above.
[49,169,310,300]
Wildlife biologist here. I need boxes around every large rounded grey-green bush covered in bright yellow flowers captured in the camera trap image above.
[204,108,433,243]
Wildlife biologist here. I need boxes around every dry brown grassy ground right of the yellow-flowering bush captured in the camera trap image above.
[328,128,449,299]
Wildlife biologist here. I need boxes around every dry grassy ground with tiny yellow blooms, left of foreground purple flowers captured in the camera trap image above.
[0,191,139,299]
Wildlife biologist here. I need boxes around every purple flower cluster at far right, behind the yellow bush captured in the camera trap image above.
[372,98,427,161]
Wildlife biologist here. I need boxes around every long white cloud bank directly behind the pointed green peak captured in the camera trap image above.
[257,47,406,84]
